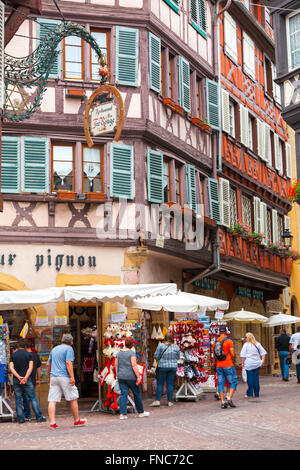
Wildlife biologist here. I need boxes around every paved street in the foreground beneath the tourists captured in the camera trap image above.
[0,376,300,451]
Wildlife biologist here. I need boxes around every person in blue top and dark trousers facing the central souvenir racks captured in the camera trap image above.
[150,333,180,406]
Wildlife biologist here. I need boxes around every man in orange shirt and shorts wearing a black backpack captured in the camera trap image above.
[214,325,237,409]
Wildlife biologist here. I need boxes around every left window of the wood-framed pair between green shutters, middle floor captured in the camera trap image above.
[52,143,75,191]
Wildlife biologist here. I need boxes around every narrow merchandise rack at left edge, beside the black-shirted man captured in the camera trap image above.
[0,321,14,420]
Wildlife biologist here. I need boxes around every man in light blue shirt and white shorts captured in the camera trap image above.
[47,333,87,429]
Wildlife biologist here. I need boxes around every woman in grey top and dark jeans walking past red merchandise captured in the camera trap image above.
[115,336,150,419]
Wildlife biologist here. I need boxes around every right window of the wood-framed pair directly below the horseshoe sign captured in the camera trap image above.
[82,145,104,193]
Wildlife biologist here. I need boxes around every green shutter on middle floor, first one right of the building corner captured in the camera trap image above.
[147,150,164,203]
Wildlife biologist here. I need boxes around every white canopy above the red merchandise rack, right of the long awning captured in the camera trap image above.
[127,291,229,313]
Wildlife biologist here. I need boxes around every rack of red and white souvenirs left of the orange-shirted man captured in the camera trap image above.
[169,320,207,401]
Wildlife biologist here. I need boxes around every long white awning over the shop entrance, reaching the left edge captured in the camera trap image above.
[0,283,177,310]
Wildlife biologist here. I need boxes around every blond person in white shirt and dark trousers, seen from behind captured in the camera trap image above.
[240,333,267,398]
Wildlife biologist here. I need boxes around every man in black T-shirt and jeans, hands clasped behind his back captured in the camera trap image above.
[9,339,46,423]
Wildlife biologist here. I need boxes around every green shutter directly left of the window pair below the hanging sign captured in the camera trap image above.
[21,137,49,193]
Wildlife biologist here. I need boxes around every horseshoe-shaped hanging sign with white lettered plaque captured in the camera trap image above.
[84,85,124,147]
